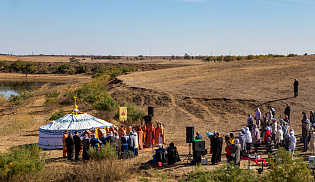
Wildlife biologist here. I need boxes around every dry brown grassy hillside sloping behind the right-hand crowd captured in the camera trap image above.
[117,56,315,148]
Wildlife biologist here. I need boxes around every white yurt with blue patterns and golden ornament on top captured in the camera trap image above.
[38,105,113,149]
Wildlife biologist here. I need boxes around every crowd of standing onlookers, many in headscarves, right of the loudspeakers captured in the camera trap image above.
[207,104,315,165]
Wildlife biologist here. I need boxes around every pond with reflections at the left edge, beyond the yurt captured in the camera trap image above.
[0,81,65,98]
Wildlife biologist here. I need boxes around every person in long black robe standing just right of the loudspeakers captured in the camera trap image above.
[211,132,223,165]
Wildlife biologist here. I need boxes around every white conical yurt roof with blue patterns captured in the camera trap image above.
[39,113,113,131]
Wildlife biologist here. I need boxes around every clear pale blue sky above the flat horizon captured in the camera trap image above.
[0,0,315,56]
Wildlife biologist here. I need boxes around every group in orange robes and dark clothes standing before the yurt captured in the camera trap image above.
[62,123,165,160]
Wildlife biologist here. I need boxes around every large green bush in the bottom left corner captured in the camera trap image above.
[0,144,45,181]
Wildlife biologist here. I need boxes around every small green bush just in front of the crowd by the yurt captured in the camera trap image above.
[88,143,118,161]
